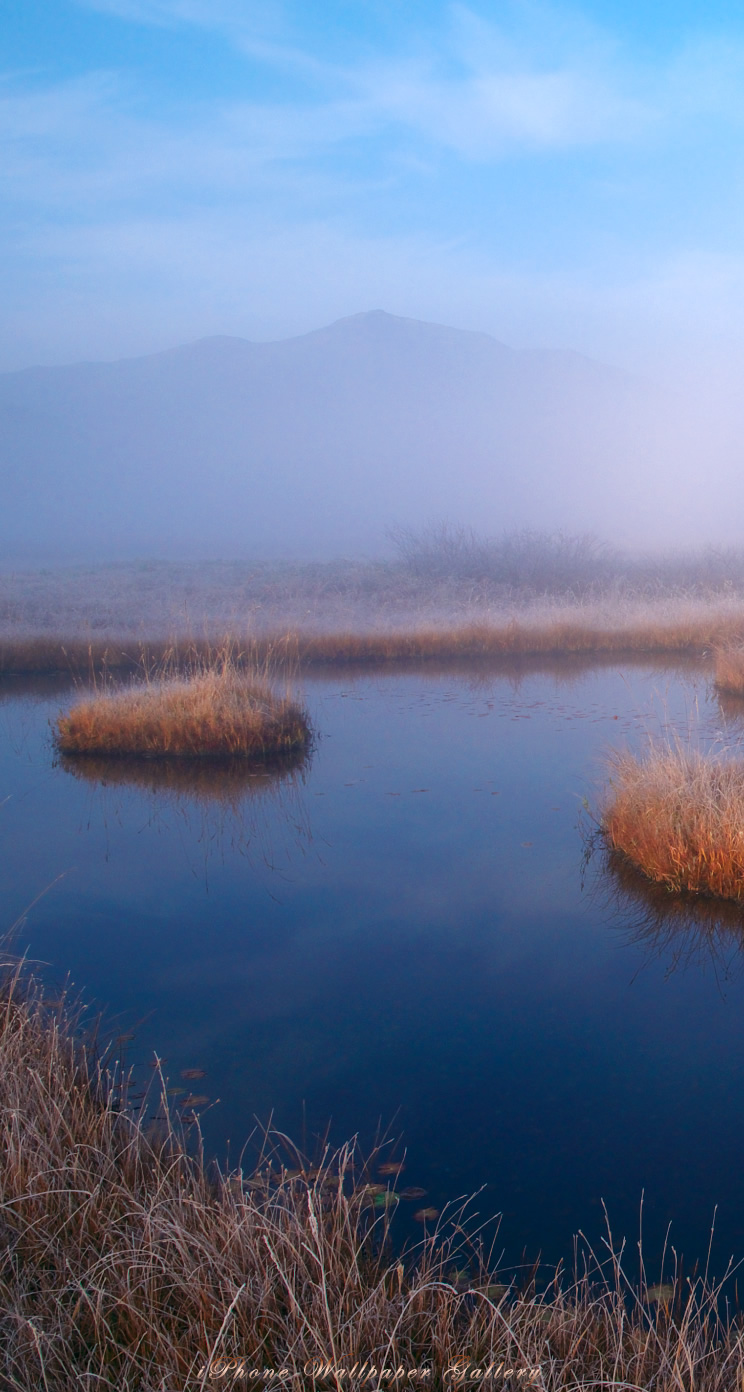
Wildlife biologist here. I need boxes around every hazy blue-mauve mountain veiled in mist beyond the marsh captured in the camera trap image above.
[0,312,743,568]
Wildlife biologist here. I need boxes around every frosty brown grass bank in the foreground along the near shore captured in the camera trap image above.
[0,970,744,1392]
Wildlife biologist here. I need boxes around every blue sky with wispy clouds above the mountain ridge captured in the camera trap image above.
[0,0,744,372]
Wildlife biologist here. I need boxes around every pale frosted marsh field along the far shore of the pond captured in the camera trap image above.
[7,525,744,672]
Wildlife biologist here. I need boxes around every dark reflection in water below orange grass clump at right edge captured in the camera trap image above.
[592,851,744,981]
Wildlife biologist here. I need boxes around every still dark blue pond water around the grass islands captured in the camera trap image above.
[0,665,744,1270]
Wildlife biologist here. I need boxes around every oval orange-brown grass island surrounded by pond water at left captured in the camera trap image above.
[56,658,309,759]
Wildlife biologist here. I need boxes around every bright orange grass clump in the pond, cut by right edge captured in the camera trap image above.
[602,746,744,903]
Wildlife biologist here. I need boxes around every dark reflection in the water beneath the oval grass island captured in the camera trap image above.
[57,749,311,807]
